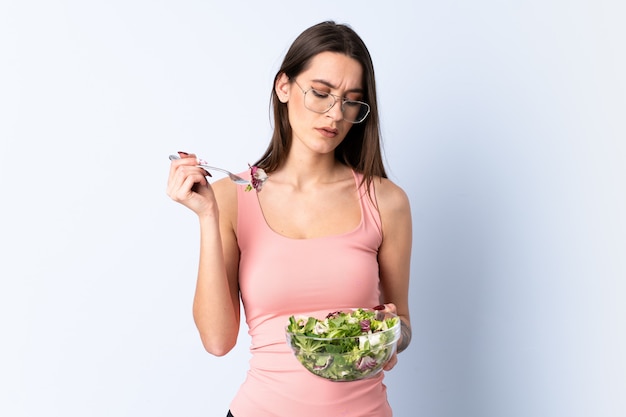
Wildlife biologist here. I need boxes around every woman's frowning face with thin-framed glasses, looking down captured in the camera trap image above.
[276,52,363,158]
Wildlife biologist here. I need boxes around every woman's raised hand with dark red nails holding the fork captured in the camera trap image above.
[167,152,217,216]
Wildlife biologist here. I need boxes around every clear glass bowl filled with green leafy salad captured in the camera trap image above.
[285,308,400,381]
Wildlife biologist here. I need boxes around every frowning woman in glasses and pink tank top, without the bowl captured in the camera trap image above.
[168,22,411,417]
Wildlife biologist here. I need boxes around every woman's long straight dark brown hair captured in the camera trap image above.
[256,21,387,191]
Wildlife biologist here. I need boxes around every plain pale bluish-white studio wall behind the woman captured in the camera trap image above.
[0,0,626,417]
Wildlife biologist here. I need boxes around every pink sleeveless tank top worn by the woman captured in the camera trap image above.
[230,173,392,417]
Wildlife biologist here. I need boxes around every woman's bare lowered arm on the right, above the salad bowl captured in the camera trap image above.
[375,179,412,324]
